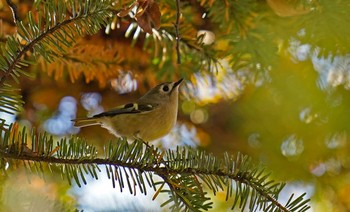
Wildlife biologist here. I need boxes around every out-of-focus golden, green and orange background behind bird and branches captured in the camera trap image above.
[0,0,350,211]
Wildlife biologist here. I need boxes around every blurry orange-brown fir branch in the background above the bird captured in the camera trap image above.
[39,40,125,87]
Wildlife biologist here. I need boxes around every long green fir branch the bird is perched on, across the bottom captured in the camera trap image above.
[0,125,309,211]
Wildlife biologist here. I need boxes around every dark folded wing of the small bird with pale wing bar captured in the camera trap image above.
[93,103,156,118]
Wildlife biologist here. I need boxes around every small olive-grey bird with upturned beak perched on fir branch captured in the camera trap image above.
[72,79,183,142]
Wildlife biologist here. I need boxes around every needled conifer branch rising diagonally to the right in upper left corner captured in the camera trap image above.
[0,0,111,87]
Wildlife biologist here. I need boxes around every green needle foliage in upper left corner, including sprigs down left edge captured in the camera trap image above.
[0,0,111,117]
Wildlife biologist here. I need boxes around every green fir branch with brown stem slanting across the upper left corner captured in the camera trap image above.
[0,0,111,87]
